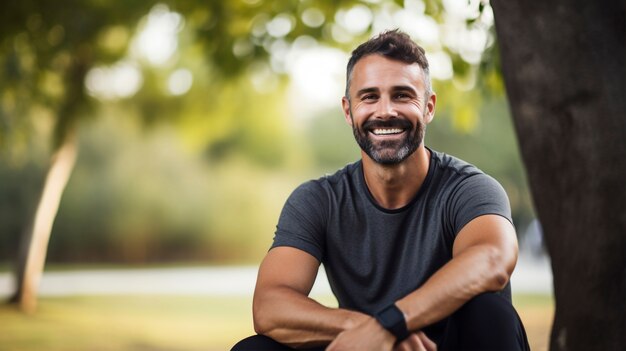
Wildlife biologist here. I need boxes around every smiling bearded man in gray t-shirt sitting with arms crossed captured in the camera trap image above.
[234,31,528,351]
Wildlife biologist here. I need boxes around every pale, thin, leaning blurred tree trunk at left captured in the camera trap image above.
[11,132,77,313]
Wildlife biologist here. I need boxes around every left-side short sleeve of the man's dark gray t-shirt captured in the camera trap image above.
[271,181,328,262]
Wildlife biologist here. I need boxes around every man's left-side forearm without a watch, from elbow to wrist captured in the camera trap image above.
[253,287,367,347]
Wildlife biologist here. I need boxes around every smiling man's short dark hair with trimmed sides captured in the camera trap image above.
[345,29,432,100]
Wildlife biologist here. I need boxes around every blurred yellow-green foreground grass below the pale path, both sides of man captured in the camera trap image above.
[0,295,553,351]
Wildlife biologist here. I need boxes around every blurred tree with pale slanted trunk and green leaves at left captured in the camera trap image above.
[0,0,368,311]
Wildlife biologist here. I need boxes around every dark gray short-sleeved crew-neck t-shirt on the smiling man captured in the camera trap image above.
[272,150,512,315]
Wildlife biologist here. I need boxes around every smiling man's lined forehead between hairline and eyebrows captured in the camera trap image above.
[350,54,424,93]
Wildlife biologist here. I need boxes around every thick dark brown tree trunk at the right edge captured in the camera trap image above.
[492,0,626,350]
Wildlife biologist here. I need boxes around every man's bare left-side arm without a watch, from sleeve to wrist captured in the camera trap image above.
[253,247,368,347]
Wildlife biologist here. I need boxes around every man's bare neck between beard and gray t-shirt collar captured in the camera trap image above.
[362,145,430,210]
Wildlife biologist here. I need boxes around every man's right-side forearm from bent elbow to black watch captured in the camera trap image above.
[396,245,516,331]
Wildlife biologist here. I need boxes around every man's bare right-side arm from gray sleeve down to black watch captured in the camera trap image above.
[396,215,517,330]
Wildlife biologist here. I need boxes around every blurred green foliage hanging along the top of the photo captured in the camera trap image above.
[0,0,502,148]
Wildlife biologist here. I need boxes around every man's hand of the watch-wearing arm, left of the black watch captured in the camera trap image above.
[326,317,392,351]
